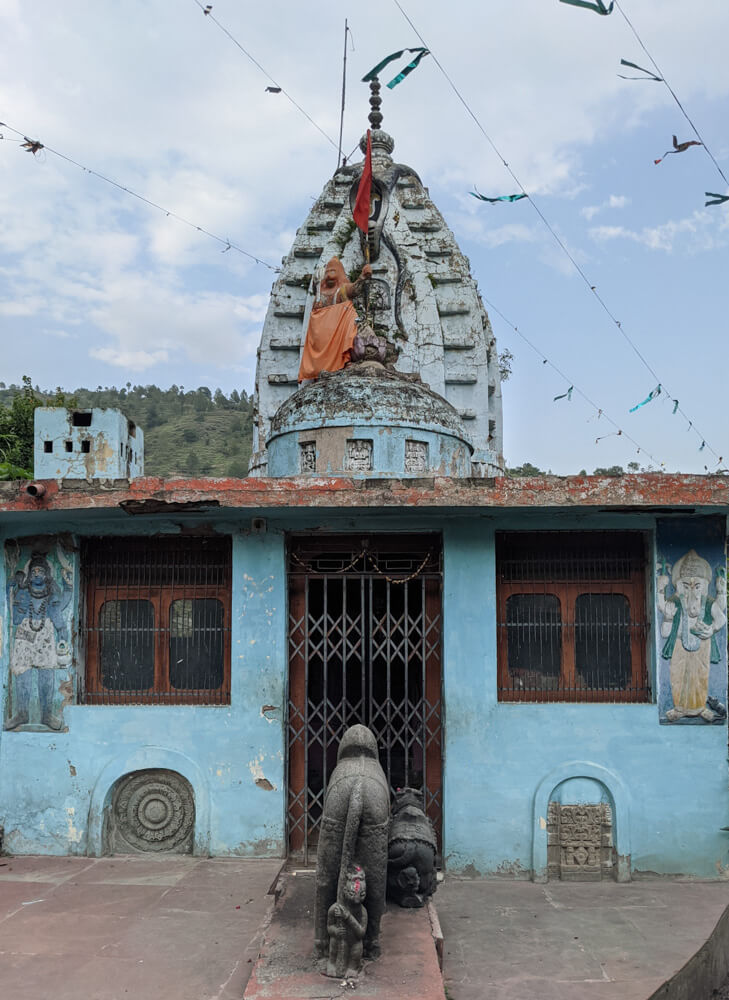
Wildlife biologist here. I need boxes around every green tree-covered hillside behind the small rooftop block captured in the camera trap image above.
[0,382,253,478]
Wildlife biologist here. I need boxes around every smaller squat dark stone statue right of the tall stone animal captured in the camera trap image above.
[387,788,437,907]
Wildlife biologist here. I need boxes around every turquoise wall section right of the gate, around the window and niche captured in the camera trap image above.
[444,519,729,878]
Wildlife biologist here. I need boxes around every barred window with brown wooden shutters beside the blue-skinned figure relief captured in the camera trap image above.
[81,537,231,705]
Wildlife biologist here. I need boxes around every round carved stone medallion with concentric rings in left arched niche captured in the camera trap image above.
[112,770,195,853]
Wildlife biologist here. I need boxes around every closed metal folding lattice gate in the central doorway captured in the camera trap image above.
[288,535,442,862]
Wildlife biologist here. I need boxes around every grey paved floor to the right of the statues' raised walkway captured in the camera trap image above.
[435,879,729,1000]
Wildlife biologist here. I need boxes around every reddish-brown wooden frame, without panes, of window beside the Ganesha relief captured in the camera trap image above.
[496,532,652,704]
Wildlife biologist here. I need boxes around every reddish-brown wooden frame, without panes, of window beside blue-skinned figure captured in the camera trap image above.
[83,538,232,705]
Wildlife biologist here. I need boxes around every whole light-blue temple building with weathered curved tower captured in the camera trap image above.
[0,86,729,884]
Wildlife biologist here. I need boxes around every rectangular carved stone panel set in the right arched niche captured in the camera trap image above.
[547,802,616,882]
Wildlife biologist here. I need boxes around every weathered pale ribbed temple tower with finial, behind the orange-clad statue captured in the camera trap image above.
[250,80,503,477]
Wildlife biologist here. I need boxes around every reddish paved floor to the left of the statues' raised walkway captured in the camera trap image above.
[0,856,281,1000]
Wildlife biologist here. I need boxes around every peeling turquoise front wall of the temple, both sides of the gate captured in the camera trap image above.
[0,509,729,878]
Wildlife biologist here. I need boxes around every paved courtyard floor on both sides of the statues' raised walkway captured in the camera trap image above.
[0,856,729,1000]
